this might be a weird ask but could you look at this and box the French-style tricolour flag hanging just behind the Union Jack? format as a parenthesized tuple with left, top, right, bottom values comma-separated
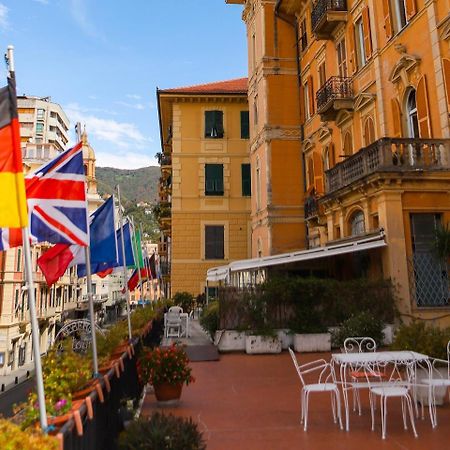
(38, 197, 117, 286)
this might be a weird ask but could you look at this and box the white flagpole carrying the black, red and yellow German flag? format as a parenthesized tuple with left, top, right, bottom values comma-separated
(7, 45, 48, 433)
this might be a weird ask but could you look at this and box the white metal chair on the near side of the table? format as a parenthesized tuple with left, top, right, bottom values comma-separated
(364, 360, 417, 439)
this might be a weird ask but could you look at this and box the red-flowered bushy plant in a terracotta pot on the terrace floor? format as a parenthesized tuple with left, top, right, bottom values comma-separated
(139, 344, 194, 402)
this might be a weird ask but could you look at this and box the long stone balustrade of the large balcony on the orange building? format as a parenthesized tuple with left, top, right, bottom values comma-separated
(326, 138, 450, 194)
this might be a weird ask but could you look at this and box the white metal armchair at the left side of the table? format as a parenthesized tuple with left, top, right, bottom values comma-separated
(289, 348, 342, 431)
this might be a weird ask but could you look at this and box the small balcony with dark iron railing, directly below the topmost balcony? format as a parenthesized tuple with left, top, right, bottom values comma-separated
(316, 77, 353, 122)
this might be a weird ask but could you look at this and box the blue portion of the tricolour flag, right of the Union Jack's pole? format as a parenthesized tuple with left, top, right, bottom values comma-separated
(77, 197, 118, 277)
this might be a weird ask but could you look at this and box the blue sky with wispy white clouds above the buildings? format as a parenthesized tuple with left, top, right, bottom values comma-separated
(0, 0, 247, 168)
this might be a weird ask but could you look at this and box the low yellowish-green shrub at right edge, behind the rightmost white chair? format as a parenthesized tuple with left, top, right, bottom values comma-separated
(392, 321, 450, 359)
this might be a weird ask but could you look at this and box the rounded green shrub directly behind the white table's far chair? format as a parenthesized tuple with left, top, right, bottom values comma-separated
(331, 311, 384, 347)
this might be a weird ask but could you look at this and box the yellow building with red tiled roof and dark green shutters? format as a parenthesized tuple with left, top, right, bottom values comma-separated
(157, 78, 251, 296)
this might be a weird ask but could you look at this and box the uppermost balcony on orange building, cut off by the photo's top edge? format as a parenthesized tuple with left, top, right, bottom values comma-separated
(311, 0, 347, 39)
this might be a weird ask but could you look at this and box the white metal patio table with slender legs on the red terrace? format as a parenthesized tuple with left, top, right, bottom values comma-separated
(331, 350, 436, 431)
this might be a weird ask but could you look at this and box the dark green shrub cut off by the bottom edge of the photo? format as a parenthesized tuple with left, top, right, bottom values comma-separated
(119, 412, 206, 450)
